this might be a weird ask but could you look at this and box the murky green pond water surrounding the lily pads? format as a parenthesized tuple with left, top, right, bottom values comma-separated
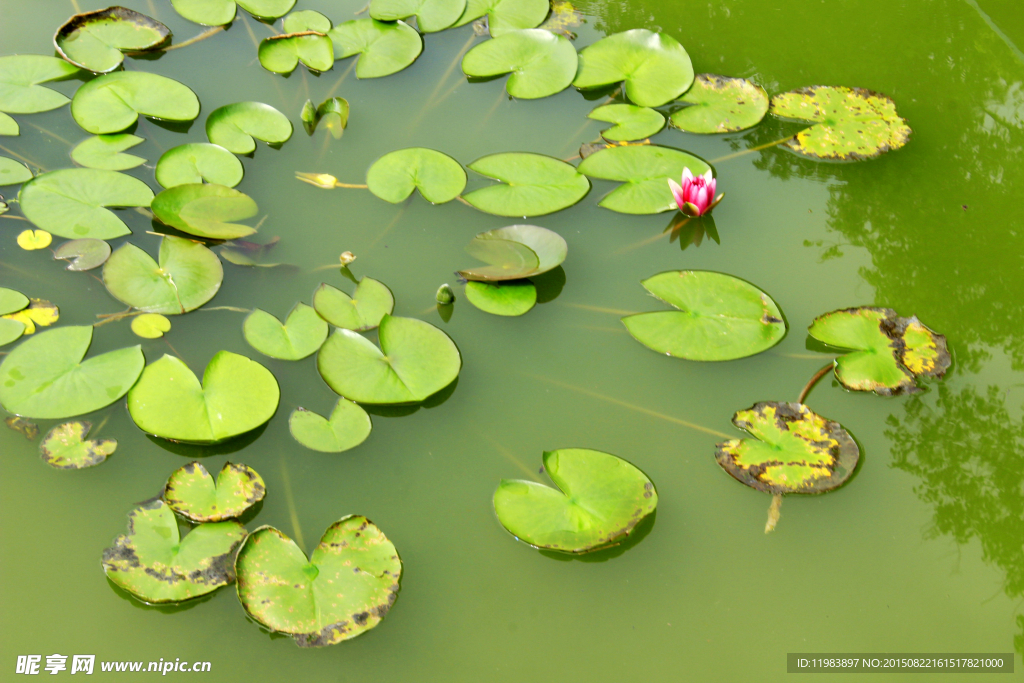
(0, 0, 1024, 683)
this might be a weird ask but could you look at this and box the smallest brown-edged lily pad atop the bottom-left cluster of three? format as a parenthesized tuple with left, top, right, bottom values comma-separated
(163, 461, 266, 522)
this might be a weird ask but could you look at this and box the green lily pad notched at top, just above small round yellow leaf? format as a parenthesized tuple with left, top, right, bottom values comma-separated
(103, 236, 224, 315)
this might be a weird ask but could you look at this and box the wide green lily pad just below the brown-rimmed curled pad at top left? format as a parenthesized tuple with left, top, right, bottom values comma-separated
(71, 71, 199, 135)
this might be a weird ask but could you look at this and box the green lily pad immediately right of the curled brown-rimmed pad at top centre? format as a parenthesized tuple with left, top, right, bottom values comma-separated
(328, 18, 423, 78)
